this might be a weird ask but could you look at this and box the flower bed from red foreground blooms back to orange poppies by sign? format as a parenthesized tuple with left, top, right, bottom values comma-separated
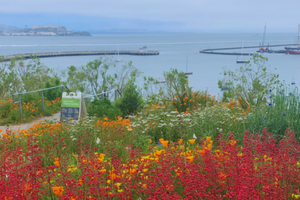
(0, 118, 300, 199)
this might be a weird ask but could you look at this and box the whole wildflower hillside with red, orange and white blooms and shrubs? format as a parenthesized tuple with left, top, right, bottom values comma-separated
(0, 55, 300, 200)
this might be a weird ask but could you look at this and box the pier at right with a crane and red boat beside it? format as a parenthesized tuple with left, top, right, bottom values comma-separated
(199, 44, 298, 56)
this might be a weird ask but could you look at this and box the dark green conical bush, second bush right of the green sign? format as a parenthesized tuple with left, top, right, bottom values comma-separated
(115, 80, 143, 116)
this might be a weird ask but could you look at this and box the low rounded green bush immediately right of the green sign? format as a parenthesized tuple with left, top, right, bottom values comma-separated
(87, 98, 122, 120)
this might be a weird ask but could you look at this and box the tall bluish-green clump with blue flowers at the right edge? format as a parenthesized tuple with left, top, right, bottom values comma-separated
(246, 87, 300, 139)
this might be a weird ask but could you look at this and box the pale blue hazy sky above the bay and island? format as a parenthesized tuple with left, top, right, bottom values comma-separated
(0, 0, 300, 32)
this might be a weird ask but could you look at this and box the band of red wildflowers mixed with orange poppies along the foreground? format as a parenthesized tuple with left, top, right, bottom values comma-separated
(0, 129, 300, 199)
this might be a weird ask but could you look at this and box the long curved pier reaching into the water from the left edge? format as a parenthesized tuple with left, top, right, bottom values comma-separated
(0, 50, 159, 62)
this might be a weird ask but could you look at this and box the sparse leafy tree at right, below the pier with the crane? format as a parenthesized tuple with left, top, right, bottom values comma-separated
(218, 55, 279, 105)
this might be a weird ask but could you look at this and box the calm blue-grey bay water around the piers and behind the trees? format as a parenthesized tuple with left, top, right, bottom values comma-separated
(0, 33, 300, 95)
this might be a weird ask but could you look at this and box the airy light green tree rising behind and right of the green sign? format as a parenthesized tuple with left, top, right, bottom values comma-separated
(67, 58, 141, 95)
